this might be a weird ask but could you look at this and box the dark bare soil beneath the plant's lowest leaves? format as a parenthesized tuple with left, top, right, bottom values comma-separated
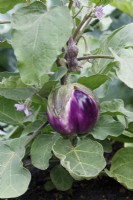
(11, 143, 133, 200)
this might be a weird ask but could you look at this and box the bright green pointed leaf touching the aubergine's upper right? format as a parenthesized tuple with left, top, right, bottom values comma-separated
(78, 74, 109, 90)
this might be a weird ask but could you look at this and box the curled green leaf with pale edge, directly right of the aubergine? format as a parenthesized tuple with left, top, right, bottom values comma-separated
(101, 99, 133, 118)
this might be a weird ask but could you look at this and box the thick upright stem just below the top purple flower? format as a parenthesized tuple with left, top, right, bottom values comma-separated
(73, 11, 92, 40)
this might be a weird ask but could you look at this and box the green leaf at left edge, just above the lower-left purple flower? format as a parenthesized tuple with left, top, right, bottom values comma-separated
(0, 73, 35, 101)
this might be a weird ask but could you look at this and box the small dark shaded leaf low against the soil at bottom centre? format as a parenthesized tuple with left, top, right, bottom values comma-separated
(50, 165, 73, 191)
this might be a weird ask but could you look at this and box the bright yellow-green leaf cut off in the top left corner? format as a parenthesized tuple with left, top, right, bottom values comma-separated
(0, 0, 26, 13)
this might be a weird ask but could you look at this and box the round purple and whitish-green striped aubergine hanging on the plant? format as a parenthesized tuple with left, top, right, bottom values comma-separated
(47, 83, 99, 135)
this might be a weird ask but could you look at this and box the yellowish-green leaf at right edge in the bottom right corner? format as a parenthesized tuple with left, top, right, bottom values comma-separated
(108, 147, 133, 190)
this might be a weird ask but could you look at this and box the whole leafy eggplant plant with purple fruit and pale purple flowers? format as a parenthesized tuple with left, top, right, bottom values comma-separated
(0, 0, 133, 199)
